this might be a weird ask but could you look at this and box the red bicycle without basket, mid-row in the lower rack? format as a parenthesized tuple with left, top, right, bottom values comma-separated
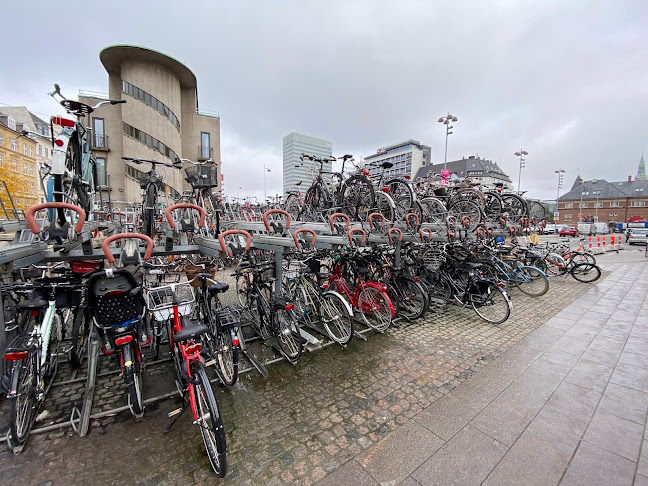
(328, 228, 394, 332)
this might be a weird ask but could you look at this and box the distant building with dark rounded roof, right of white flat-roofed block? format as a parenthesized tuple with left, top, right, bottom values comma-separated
(416, 155, 513, 190)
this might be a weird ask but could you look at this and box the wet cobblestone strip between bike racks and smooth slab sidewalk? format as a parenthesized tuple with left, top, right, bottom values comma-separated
(0, 264, 607, 486)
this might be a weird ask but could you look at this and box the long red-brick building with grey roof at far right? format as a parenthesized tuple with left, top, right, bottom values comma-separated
(558, 155, 648, 225)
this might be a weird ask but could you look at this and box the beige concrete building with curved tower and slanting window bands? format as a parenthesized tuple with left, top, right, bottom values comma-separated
(79, 45, 221, 207)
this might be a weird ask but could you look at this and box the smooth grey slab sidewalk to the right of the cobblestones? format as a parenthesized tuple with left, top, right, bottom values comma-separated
(318, 248, 648, 486)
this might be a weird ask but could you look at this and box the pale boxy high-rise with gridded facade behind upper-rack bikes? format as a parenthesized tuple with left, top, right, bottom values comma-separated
(283, 132, 333, 197)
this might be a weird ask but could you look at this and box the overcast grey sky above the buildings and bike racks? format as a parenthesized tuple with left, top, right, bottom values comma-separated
(0, 0, 648, 199)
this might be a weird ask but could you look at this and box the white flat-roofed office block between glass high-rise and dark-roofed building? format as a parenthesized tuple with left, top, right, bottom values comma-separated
(364, 139, 431, 180)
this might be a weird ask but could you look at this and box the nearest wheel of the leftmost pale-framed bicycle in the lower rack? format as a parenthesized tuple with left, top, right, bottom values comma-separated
(9, 352, 38, 449)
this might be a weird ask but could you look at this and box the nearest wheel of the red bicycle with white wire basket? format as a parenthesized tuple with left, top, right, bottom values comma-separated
(191, 361, 227, 478)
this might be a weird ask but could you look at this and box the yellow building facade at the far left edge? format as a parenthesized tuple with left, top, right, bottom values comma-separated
(0, 115, 39, 214)
